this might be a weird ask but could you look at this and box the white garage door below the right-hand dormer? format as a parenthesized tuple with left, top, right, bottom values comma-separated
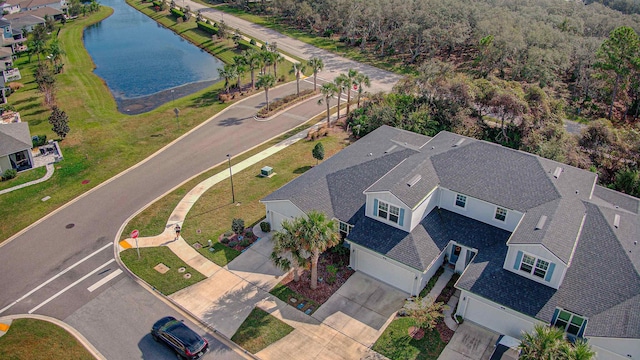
(464, 296, 533, 338)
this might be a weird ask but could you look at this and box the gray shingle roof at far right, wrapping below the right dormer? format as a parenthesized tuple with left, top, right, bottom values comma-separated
(457, 203, 640, 338)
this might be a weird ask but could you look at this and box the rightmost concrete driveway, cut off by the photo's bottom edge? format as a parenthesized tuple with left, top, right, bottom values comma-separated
(438, 321, 499, 360)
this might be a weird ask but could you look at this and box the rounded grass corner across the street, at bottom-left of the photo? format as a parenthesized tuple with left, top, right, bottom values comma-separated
(0, 319, 95, 360)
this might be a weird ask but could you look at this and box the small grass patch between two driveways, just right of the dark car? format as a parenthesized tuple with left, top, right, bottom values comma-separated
(231, 308, 293, 354)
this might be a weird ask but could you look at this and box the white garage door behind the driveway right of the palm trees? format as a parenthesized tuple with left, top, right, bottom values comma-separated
(356, 249, 415, 293)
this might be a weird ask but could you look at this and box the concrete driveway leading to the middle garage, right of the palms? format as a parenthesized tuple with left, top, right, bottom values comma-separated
(312, 272, 409, 347)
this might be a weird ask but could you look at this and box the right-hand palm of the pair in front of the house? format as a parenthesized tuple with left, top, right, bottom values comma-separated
(299, 210, 340, 290)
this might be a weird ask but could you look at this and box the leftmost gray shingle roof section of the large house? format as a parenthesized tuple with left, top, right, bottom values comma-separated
(262, 126, 429, 224)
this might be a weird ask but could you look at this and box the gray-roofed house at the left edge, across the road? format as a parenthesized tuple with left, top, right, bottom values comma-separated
(0, 122, 33, 173)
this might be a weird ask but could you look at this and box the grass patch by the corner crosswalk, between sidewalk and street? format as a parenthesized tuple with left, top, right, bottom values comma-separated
(120, 246, 206, 295)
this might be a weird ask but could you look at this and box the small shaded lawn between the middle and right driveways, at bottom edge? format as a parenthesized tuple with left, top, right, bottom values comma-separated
(373, 317, 447, 360)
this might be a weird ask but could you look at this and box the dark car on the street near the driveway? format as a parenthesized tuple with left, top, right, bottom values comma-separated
(151, 316, 209, 359)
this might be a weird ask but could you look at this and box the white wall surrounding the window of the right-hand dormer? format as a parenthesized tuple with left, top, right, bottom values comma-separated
(502, 244, 567, 289)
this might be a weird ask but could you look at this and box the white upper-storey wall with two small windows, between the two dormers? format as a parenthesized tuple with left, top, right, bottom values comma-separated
(438, 187, 523, 232)
